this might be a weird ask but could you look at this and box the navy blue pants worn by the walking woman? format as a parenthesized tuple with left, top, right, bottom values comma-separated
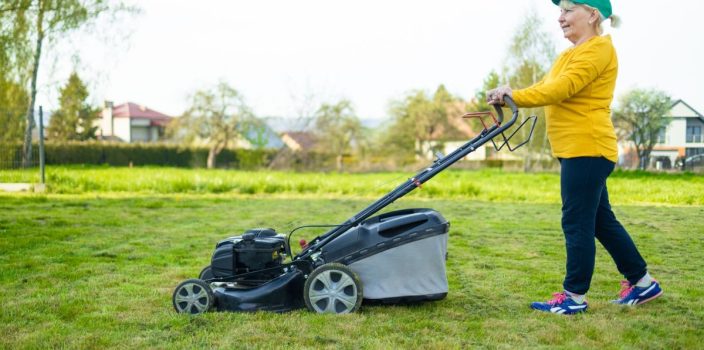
(560, 157, 646, 294)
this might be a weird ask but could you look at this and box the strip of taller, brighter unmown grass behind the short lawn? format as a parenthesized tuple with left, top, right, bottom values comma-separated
(0, 167, 704, 205)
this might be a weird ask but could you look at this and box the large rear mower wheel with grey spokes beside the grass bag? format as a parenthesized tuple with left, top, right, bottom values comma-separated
(303, 263, 362, 314)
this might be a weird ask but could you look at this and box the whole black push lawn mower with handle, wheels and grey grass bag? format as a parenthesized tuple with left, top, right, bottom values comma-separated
(172, 97, 536, 314)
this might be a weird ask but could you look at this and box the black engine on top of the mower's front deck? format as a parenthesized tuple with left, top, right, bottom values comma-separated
(210, 228, 286, 284)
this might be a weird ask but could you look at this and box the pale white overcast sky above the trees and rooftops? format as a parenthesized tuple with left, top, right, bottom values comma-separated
(38, 0, 704, 119)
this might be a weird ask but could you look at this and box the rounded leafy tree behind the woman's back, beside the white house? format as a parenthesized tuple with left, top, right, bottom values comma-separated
(613, 89, 672, 170)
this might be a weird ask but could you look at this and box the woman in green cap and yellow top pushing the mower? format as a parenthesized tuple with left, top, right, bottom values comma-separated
(487, 0, 662, 315)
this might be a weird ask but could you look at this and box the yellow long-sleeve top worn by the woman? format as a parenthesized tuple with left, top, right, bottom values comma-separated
(513, 35, 618, 162)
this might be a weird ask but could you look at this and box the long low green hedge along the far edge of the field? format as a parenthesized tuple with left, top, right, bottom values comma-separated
(0, 142, 554, 171)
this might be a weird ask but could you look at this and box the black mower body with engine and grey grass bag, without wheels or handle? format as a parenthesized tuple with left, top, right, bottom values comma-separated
(206, 209, 450, 312)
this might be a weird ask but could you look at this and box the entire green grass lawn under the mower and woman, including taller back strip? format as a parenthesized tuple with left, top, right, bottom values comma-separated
(0, 168, 704, 349)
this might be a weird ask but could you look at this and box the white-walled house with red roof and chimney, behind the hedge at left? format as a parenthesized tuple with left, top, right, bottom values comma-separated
(95, 101, 173, 143)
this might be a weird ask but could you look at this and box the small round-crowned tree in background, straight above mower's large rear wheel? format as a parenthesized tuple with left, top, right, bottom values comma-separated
(314, 100, 362, 171)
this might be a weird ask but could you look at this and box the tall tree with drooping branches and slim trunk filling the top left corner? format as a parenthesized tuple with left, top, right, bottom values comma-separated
(0, 0, 130, 166)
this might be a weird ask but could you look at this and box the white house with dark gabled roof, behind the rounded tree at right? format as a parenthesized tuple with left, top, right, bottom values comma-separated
(619, 100, 704, 169)
